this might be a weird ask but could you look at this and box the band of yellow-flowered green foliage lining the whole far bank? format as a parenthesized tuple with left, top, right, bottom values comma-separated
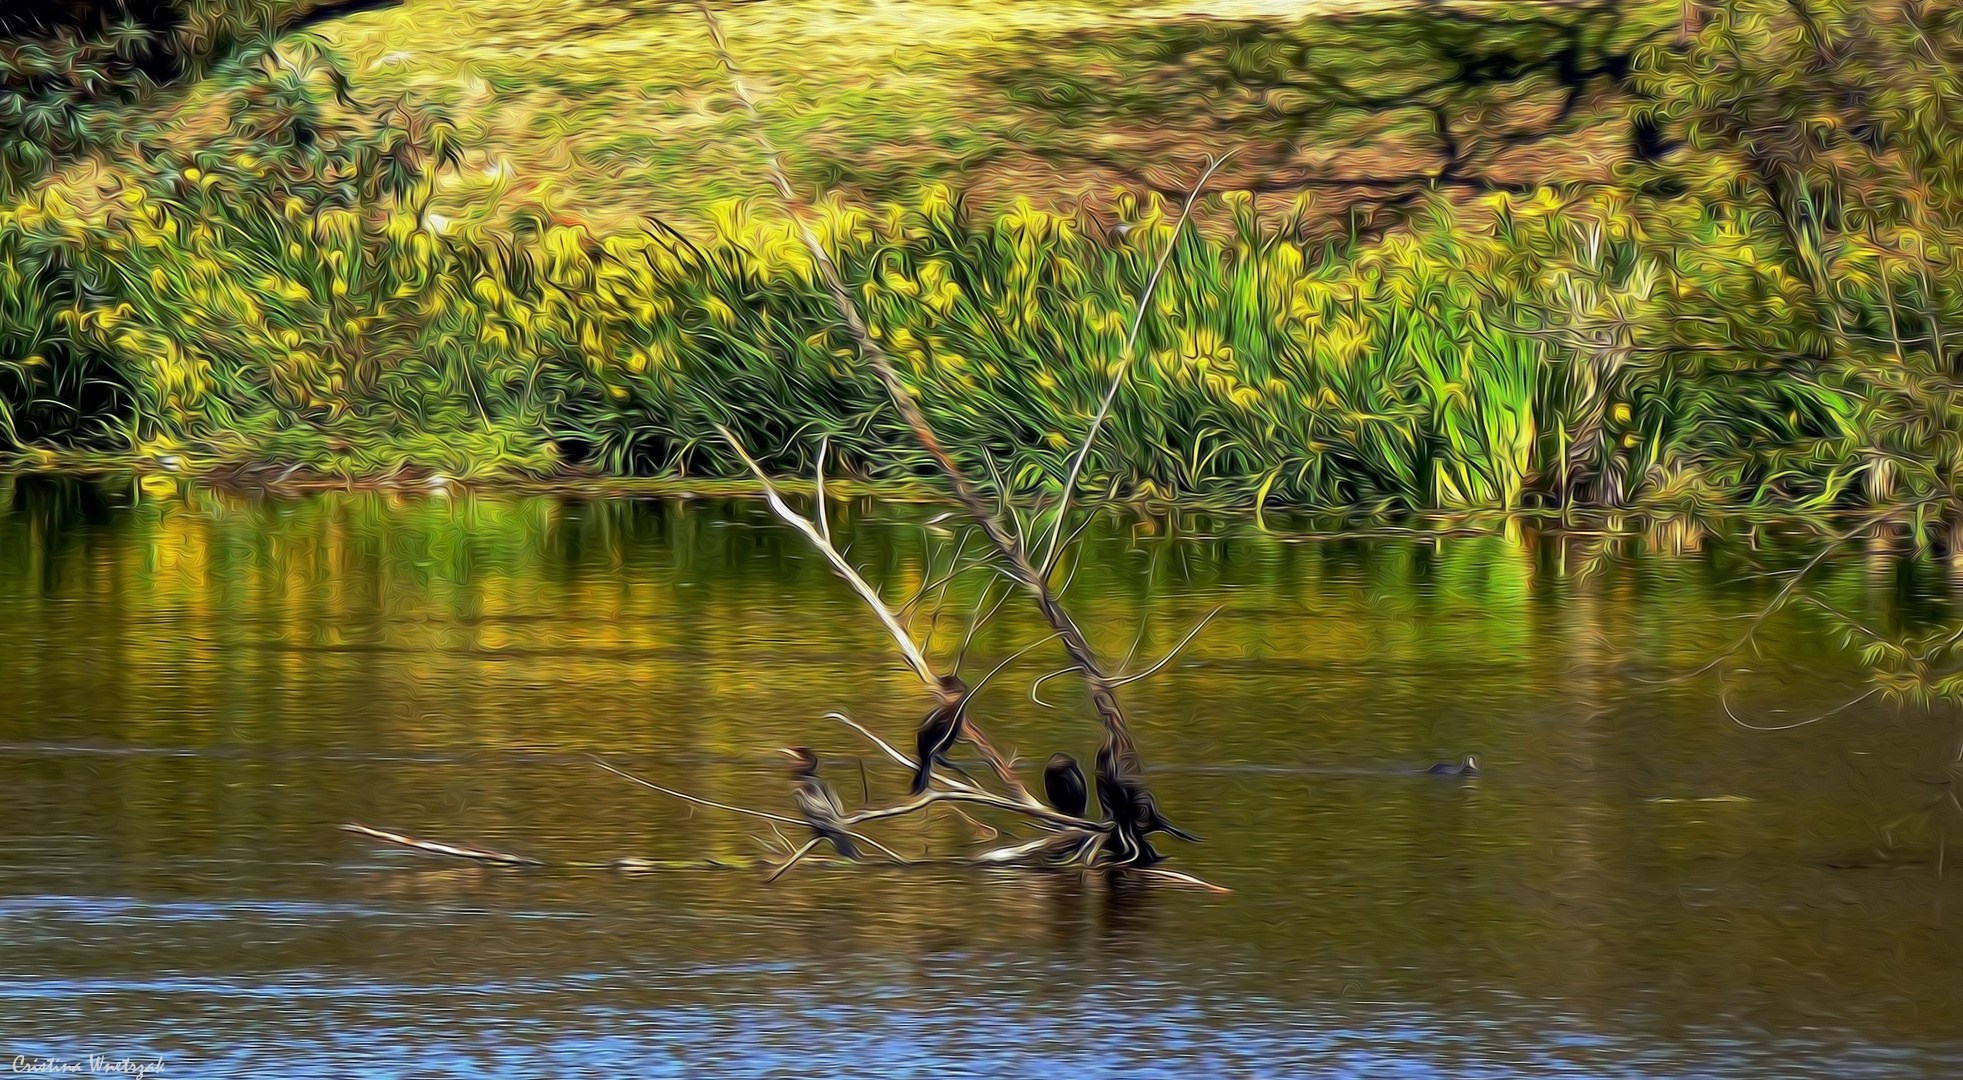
(0, 0, 1963, 520)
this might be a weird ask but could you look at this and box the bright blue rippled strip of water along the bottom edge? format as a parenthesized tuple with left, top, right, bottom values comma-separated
(0, 964, 1963, 1080)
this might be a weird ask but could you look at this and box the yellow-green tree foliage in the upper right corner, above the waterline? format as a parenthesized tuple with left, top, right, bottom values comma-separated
(1643, 0, 1963, 524)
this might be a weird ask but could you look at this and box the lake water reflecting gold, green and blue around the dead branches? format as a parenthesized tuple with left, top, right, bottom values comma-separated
(0, 479, 1963, 1078)
